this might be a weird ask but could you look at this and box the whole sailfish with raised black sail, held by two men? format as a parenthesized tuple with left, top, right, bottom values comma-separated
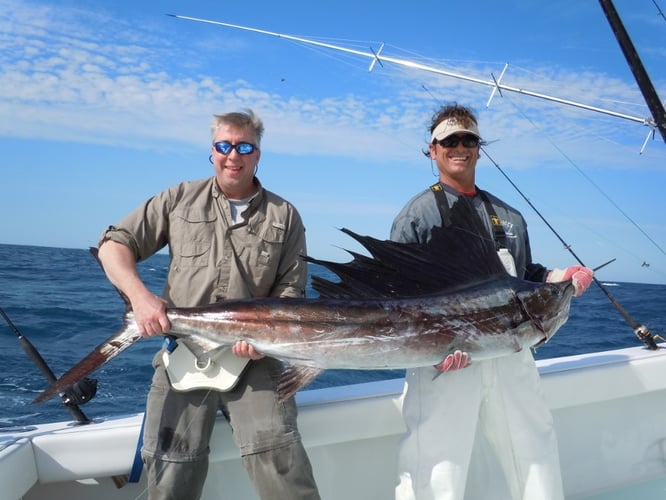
(35, 197, 574, 402)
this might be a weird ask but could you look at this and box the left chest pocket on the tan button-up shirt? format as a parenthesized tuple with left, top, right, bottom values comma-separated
(169, 209, 217, 268)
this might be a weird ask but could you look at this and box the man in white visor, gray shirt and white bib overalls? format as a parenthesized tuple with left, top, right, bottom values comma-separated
(391, 104, 592, 500)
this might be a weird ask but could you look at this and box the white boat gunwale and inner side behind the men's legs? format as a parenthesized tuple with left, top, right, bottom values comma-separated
(0, 346, 666, 500)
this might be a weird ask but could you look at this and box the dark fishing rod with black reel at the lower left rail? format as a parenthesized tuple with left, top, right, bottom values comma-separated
(0, 307, 97, 424)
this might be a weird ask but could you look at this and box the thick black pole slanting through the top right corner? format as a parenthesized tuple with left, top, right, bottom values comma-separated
(599, 0, 666, 143)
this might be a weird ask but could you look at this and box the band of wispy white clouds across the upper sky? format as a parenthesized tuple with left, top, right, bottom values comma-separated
(0, 0, 660, 165)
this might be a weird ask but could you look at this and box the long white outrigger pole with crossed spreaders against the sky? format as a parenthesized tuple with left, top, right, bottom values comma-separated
(167, 14, 666, 135)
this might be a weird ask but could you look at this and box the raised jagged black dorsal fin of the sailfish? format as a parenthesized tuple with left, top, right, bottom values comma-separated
(307, 197, 506, 298)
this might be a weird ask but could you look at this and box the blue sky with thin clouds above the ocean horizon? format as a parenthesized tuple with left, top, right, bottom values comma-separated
(0, 0, 666, 283)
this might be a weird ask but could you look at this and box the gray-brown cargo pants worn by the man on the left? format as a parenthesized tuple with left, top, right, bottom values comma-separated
(142, 351, 320, 500)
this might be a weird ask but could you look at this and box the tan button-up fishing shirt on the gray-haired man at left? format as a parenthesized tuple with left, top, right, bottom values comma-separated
(102, 177, 307, 307)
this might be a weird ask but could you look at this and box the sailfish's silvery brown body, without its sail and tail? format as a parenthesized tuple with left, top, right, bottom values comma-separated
(168, 276, 573, 370)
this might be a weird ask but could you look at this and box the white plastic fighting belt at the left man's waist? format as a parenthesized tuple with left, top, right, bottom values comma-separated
(162, 340, 250, 392)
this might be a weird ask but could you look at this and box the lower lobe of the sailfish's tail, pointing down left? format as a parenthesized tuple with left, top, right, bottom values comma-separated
(33, 320, 141, 404)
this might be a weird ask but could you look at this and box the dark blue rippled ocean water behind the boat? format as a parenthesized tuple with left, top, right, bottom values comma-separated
(0, 244, 666, 427)
